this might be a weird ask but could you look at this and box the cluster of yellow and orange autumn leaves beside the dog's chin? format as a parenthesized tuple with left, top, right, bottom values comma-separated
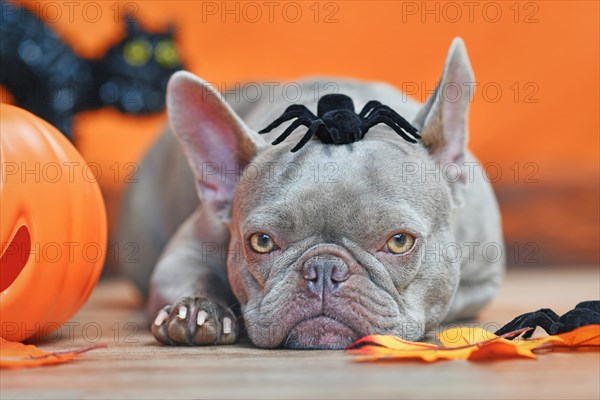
(346, 324, 600, 362)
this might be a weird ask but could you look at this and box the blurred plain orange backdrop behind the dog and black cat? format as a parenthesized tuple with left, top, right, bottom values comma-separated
(9, 1, 600, 268)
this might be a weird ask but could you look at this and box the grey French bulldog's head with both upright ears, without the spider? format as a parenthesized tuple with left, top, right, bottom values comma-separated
(167, 39, 474, 348)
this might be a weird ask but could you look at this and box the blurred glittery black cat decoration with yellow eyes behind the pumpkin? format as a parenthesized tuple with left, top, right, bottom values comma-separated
(0, 0, 182, 138)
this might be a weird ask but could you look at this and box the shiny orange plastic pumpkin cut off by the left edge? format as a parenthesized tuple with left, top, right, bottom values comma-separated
(0, 104, 107, 341)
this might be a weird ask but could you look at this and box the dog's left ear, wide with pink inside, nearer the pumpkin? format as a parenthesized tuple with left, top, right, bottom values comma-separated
(167, 71, 265, 216)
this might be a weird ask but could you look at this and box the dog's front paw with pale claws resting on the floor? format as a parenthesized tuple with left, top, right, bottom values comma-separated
(152, 297, 238, 346)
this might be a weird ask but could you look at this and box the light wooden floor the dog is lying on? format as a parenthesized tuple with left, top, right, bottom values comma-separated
(0, 267, 600, 400)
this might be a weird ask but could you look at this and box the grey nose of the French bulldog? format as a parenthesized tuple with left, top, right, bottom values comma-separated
(302, 256, 350, 295)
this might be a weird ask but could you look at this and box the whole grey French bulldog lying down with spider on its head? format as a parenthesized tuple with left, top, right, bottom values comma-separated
(119, 38, 504, 349)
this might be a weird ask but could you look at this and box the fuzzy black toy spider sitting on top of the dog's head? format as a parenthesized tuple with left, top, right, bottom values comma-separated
(258, 94, 421, 153)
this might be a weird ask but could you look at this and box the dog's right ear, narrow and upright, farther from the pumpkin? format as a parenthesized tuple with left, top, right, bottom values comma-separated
(413, 37, 475, 203)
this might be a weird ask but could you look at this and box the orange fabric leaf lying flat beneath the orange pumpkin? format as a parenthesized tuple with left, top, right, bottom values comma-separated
(0, 337, 106, 368)
